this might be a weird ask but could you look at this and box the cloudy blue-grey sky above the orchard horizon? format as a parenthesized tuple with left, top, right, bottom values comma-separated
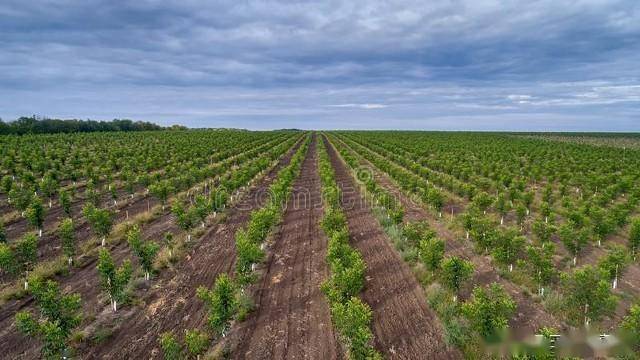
(0, 0, 640, 131)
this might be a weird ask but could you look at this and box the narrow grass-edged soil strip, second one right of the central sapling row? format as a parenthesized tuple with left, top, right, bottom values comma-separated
(330, 134, 566, 338)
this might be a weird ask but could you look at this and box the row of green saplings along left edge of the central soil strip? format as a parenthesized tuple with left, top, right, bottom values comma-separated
(159, 134, 308, 360)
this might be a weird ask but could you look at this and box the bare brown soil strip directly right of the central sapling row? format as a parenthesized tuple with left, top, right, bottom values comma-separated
(323, 136, 462, 359)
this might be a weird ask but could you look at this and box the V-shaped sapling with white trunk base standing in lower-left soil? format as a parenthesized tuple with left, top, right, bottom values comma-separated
(97, 249, 132, 312)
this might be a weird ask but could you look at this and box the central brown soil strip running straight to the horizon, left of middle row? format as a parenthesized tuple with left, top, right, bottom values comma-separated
(229, 135, 341, 359)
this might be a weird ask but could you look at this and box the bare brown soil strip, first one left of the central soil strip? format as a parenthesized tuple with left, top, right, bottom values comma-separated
(81, 141, 302, 359)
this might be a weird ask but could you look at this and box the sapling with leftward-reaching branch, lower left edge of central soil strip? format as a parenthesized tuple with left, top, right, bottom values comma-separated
(197, 273, 238, 337)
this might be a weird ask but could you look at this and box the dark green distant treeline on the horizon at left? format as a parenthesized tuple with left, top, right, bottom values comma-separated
(0, 116, 164, 135)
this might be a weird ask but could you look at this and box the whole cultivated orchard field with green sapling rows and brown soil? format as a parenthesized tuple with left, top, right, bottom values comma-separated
(0, 130, 640, 359)
